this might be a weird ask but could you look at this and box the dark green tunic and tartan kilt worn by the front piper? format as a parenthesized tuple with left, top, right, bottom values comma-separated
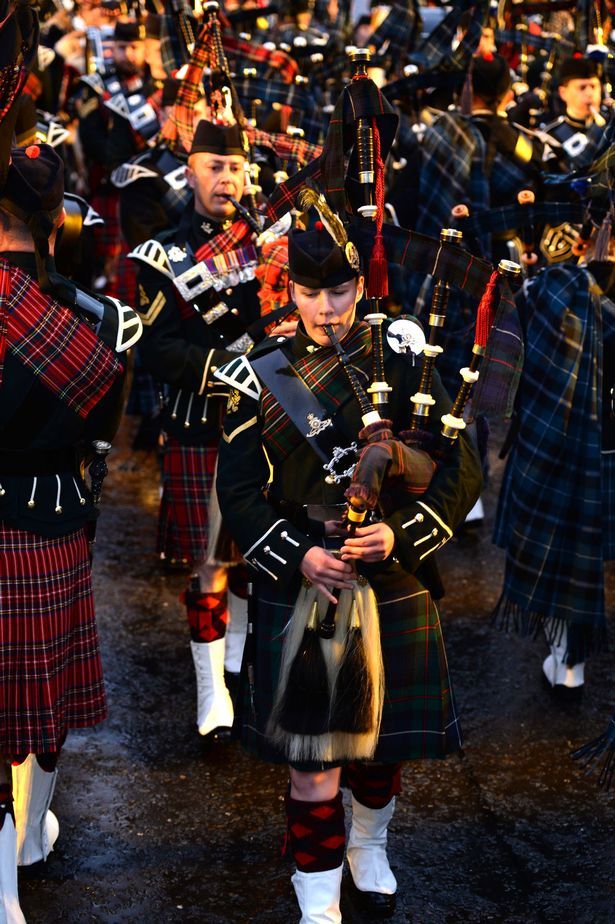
(217, 323, 481, 762)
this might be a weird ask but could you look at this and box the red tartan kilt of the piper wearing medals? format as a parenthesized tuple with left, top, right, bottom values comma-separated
(156, 437, 218, 567)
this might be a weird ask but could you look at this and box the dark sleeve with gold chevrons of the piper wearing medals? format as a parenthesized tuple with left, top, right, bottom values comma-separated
(135, 266, 237, 395)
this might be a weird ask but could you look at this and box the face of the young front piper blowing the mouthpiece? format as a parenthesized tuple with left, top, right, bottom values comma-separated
(288, 276, 363, 346)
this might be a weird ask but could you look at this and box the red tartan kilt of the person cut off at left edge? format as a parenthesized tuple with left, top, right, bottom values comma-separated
(0, 523, 107, 755)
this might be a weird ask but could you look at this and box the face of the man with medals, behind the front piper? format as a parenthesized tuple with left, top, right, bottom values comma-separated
(186, 154, 245, 221)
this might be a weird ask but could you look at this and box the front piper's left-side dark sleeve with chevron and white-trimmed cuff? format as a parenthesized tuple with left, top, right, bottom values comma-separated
(216, 390, 314, 587)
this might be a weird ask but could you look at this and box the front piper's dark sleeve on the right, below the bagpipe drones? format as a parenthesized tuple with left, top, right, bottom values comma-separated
(385, 372, 482, 574)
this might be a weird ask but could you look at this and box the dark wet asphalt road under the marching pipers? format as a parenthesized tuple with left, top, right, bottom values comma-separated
(20, 419, 615, 924)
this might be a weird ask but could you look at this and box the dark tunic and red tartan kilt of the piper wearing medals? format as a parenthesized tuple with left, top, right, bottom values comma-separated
(132, 212, 260, 566)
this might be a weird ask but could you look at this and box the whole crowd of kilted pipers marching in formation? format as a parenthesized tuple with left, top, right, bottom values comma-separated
(0, 0, 615, 924)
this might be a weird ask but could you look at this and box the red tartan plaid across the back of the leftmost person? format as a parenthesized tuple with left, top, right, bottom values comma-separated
(0, 260, 122, 418)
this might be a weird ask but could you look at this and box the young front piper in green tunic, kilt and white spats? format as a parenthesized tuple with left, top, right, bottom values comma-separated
(218, 229, 481, 924)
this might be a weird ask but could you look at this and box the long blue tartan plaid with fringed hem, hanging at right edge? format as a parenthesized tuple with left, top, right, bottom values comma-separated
(494, 266, 614, 661)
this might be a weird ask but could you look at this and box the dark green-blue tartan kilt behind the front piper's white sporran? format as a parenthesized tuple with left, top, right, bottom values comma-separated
(241, 562, 462, 763)
